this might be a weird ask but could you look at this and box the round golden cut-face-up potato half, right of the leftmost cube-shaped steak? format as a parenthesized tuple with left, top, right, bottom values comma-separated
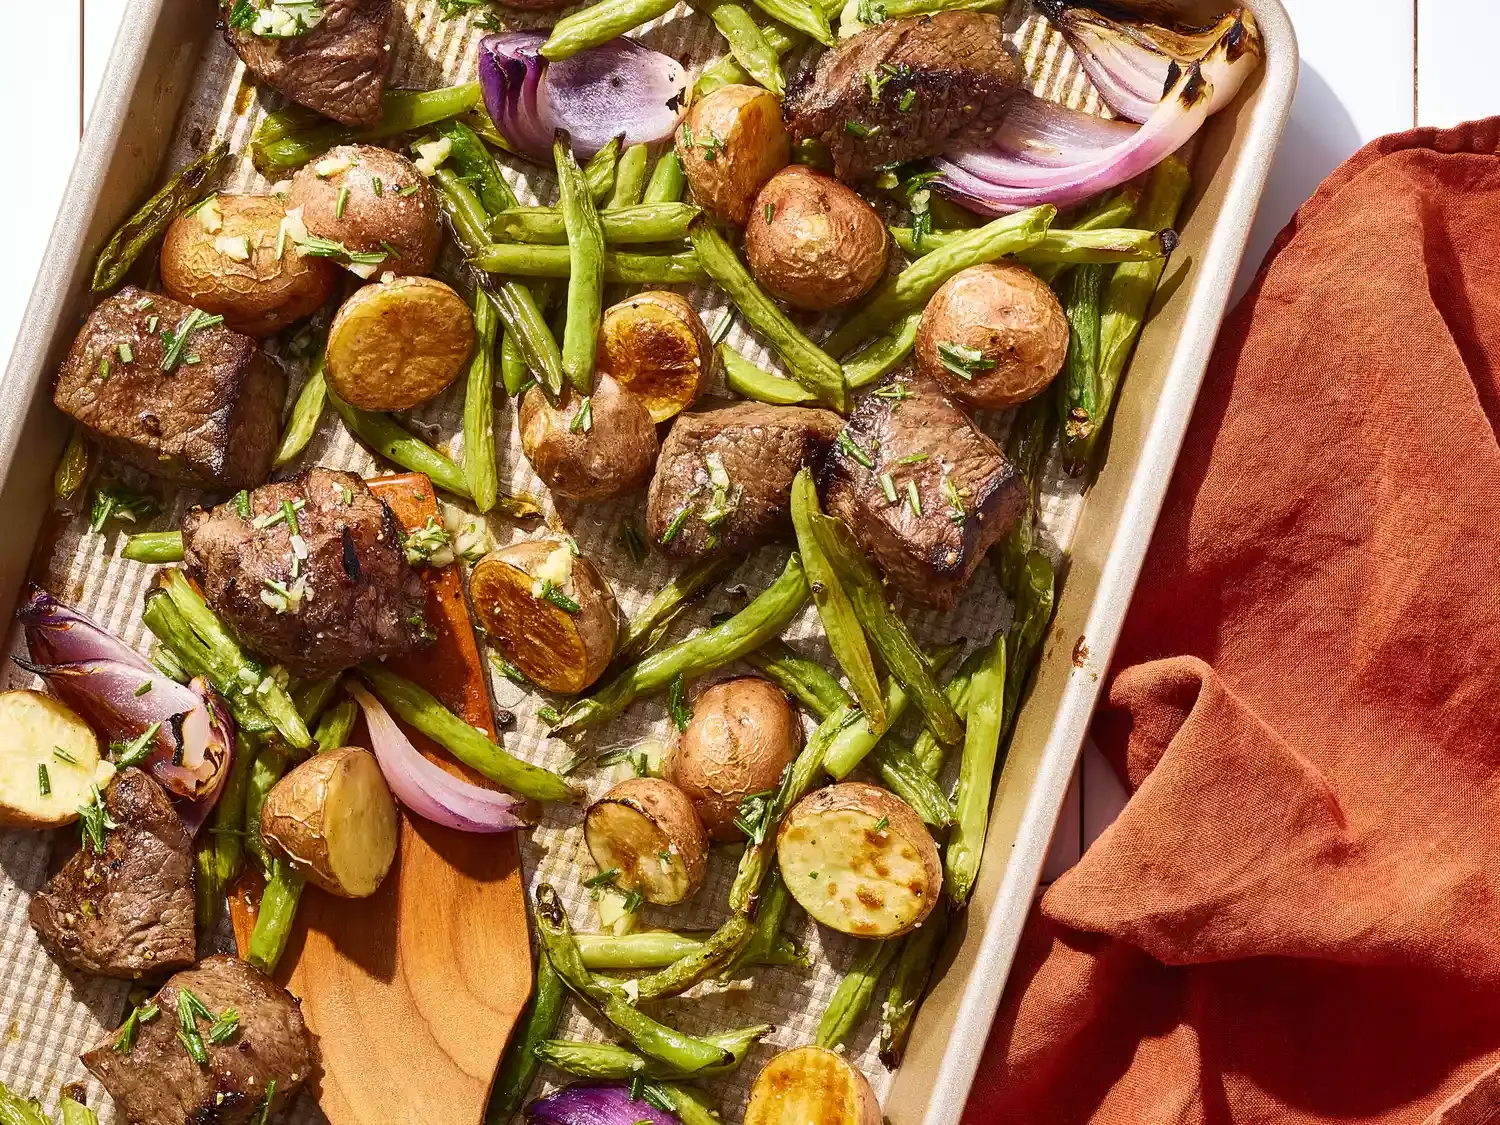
(327, 278, 474, 411)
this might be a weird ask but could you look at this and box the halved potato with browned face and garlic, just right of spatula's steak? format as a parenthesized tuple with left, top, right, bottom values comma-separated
(470, 539, 620, 695)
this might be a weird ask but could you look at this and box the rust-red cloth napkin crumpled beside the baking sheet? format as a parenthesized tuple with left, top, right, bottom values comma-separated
(965, 119, 1500, 1125)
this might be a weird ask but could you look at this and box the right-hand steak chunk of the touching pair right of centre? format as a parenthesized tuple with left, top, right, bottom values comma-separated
(822, 374, 1026, 609)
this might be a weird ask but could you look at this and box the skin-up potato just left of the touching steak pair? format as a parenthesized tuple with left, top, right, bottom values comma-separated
(518, 372, 659, 500)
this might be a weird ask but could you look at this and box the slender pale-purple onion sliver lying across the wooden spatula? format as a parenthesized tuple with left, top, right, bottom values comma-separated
(344, 680, 528, 833)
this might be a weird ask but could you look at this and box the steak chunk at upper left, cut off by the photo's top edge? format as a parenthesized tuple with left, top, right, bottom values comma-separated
(221, 0, 393, 125)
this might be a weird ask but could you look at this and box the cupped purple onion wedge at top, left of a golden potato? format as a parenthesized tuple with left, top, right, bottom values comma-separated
(479, 32, 689, 165)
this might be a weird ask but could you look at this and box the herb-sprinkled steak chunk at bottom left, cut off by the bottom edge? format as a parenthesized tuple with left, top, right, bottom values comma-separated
(81, 954, 314, 1125)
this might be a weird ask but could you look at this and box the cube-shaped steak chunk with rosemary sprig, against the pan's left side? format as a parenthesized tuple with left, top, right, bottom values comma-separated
(53, 285, 287, 489)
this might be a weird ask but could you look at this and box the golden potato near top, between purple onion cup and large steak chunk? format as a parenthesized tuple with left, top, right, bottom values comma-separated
(677, 86, 792, 227)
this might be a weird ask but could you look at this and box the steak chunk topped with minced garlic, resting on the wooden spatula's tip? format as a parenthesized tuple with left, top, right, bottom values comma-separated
(183, 468, 428, 677)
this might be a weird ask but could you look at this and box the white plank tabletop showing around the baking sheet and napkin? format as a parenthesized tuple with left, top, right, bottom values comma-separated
(0, 0, 1500, 879)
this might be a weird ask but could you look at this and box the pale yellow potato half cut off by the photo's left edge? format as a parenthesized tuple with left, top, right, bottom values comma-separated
(0, 692, 114, 828)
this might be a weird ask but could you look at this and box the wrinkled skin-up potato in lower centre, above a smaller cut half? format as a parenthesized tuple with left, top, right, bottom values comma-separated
(663, 677, 803, 842)
